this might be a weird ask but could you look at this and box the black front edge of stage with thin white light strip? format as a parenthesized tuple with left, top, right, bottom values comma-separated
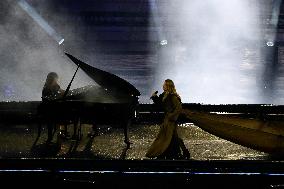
(0, 159, 283, 188)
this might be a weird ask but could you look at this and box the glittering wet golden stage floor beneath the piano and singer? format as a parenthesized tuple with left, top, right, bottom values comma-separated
(0, 124, 271, 160)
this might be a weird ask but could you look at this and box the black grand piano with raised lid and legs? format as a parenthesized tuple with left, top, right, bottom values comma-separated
(36, 53, 140, 147)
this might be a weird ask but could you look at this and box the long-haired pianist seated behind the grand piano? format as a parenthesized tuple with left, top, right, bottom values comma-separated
(41, 72, 64, 102)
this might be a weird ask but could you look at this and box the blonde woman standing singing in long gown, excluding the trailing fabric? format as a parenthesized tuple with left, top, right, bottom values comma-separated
(146, 79, 190, 159)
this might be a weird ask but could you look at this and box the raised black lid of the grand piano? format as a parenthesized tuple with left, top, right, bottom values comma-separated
(65, 52, 140, 96)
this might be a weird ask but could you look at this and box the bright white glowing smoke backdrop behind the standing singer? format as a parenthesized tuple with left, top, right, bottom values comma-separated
(152, 0, 264, 104)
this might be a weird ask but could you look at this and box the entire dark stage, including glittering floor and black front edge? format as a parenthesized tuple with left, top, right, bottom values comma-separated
(0, 102, 284, 188)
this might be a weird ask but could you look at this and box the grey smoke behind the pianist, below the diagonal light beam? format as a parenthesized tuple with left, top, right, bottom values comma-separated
(0, 0, 93, 101)
